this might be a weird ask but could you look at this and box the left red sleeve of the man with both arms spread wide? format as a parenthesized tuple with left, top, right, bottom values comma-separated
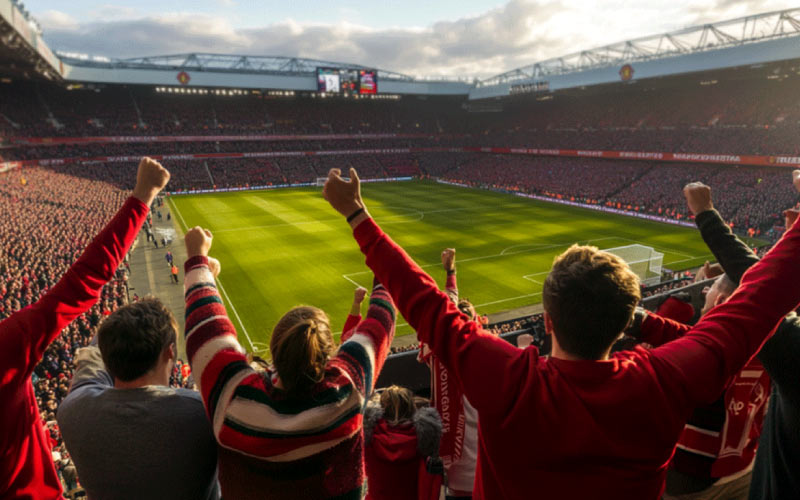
(354, 219, 538, 413)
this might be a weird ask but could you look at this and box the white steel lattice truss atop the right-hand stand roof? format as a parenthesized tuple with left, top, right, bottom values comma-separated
(478, 8, 800, 86)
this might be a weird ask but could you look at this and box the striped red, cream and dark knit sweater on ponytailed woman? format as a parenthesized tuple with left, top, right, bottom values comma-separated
(185, 257, 395, 499)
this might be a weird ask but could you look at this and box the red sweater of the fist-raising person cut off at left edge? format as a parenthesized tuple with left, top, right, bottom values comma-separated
(0, 197, 147, 500)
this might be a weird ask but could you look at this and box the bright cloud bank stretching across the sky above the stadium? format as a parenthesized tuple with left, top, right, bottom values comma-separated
(39, 0, 788, 77)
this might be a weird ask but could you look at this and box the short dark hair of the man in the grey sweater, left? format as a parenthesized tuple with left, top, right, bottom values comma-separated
(97, 297, 178, 382)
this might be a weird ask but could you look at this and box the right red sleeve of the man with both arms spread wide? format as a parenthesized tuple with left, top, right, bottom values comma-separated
(651, 217, 800, 407)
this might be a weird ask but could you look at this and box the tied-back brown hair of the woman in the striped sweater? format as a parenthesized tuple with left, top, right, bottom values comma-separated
(269, 306, 336, 394)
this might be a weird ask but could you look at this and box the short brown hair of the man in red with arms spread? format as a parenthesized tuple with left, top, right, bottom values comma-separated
(542, 245, 641, 359)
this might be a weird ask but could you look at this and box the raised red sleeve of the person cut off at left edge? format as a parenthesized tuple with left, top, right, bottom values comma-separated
(0, 197, 148, 387)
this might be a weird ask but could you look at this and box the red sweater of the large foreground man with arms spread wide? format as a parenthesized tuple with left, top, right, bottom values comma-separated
(354, 219, 800, 499)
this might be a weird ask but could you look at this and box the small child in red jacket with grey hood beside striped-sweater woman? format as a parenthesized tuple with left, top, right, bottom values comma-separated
(364, 385, 442, 500)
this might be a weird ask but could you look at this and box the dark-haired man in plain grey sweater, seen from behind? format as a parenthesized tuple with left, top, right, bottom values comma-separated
(58, 297, 219, 500)
